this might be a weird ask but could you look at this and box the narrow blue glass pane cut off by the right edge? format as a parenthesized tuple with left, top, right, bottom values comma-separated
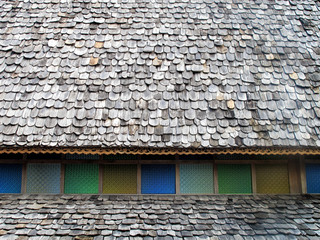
(306, 164, 320, 193)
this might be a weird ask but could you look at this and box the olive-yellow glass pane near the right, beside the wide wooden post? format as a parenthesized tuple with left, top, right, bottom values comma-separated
(256, 164, 290, 194)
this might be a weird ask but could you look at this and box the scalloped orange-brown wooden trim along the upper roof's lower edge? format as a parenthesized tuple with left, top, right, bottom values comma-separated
(0, 147, 320, 155)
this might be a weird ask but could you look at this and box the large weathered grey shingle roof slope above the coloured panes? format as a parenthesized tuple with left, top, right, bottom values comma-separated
(0, 0, 320, 147)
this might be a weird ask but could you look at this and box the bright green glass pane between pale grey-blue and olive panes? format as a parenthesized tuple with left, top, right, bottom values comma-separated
(64, 164, 99, 194)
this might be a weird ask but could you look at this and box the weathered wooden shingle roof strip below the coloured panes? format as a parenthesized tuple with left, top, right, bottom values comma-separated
(0, 195, 320, 240)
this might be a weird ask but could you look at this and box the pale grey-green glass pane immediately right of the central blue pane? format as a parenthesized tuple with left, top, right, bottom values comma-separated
(180, 164, 214, 194)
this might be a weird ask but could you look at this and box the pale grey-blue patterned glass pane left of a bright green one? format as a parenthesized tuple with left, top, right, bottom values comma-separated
(27, 163, 61, 193)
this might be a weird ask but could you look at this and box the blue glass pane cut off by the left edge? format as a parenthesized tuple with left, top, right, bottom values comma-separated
(0, 164, 22, 193)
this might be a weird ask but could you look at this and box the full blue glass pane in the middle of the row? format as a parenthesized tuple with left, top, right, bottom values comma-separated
(141, 164, 176, 194)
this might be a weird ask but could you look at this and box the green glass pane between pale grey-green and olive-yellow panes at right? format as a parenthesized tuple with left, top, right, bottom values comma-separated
(218, 164, 252, 194)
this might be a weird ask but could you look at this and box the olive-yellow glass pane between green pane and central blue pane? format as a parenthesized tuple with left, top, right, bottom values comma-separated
(103, 164, 137, 194)
